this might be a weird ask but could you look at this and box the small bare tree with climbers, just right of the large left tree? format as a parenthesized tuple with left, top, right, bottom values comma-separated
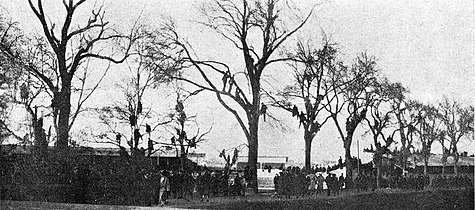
(93, 60, 173, 156)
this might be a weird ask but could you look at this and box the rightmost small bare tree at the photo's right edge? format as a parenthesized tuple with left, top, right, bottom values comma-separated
(439, 97, 474, 174)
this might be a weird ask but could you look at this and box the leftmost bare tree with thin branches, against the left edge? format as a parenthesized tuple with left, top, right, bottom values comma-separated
(0, 16, 45, 144)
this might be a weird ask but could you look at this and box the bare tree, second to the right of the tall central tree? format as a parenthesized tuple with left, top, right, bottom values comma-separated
(325, 53, 377, 182)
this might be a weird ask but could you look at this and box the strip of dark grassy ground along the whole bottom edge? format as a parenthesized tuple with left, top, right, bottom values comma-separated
(0, 189, 474, 210)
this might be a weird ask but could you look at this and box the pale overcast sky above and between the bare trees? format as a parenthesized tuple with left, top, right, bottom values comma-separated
(0, 0, 475, 162)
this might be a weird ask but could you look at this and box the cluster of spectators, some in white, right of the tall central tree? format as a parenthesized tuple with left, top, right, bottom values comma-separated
(274, 167, 345, 197)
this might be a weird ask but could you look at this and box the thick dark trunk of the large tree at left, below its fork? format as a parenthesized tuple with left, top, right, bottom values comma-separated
(57, 82, 71, 149)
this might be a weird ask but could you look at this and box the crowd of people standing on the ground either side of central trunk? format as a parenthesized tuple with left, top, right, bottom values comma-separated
(148, 167, 473, 205)
